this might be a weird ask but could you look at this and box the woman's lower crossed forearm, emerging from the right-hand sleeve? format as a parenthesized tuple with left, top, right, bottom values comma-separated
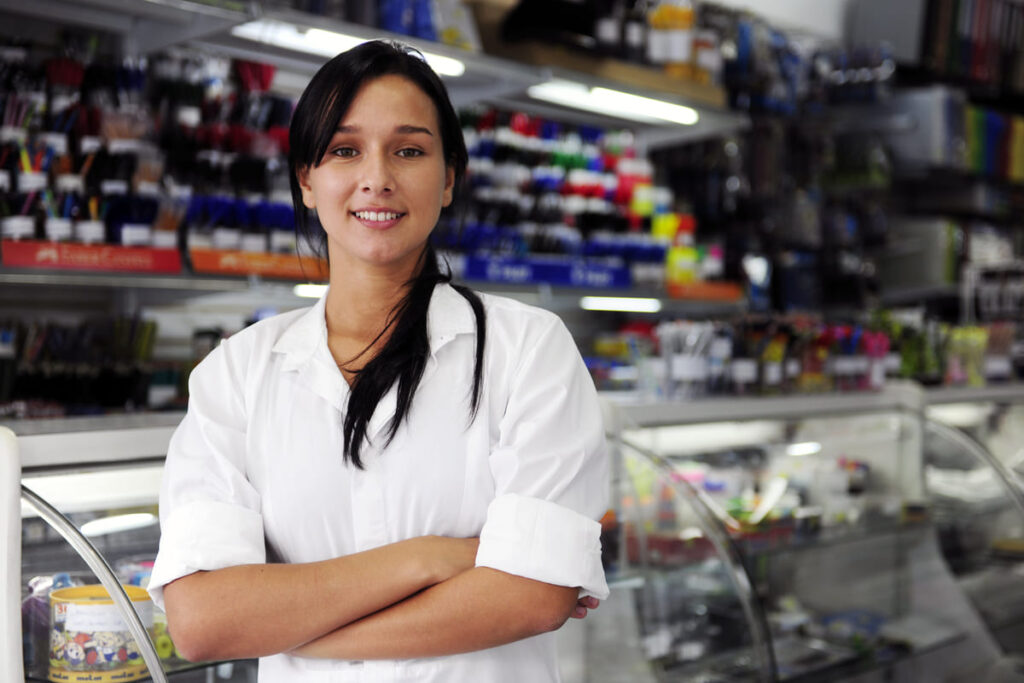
(292, 567, 580, 659)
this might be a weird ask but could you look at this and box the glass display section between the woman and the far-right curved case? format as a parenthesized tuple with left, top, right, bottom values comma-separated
(595, 408, 997, 681)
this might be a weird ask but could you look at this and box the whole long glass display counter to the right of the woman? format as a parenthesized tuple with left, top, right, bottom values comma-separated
(591, 383, 1024, 682)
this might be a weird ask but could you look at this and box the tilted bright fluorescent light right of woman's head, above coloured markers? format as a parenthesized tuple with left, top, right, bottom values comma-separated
(526, 79, 699, 126)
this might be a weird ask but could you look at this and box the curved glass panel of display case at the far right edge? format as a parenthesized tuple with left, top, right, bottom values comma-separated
(925, 404, 1024, 658)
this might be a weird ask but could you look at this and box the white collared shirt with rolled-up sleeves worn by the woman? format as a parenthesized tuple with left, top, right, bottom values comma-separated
(150, 285, 608, 683)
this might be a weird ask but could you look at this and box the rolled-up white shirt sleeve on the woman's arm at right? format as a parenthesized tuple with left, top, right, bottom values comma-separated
(476, 318, 609, 599)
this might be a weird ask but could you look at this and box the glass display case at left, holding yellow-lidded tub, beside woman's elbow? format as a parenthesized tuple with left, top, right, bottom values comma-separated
(0, 415, 256, 683)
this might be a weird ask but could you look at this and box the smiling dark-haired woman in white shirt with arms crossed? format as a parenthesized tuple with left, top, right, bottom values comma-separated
(150, 42, 608, 683)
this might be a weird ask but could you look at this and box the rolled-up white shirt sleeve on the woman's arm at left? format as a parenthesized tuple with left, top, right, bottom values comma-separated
(148, 345, 266, 608)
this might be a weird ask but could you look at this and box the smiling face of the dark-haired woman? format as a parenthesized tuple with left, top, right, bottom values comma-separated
(299, 75, 455, 276)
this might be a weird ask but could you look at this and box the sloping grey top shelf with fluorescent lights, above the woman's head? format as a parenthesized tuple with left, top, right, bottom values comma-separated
(0, 0, 748, 146)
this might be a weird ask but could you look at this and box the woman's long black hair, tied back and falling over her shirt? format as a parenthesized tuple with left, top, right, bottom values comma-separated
(288, 41, 486, 469)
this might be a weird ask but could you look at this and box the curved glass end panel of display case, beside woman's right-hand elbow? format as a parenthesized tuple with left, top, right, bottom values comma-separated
(588, 441, 771, 682)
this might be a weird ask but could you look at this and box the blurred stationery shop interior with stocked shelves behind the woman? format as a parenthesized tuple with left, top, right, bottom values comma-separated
(6, 0, 1024, 683)
